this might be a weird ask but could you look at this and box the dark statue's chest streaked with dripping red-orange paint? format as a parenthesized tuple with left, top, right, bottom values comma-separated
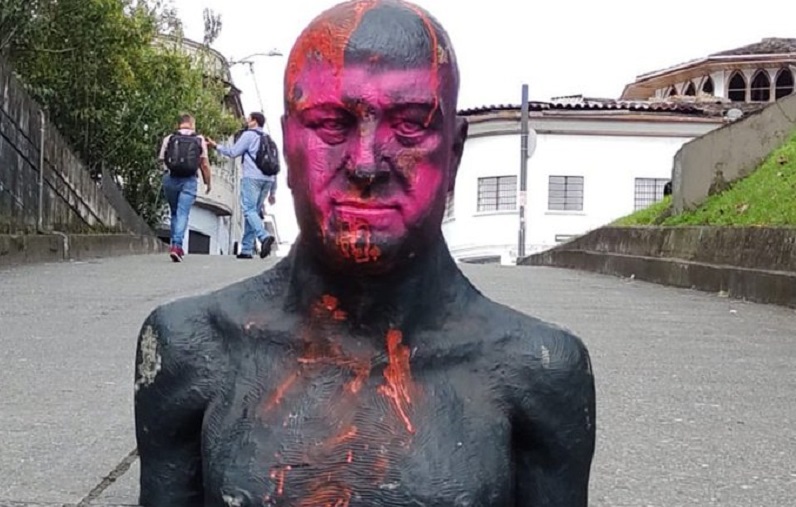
(203, 342, 512, 507)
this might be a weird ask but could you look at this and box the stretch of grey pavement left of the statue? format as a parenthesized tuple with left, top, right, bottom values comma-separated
(0, 254, 274, 506)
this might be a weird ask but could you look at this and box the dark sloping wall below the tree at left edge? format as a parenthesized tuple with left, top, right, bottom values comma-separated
(0, 61, 152, 235)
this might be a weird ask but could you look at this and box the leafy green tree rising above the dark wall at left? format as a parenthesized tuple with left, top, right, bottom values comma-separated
(0, 0, 238, 225)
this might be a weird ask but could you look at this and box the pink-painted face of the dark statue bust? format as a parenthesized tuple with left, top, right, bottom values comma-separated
(284, 63, 453, 268)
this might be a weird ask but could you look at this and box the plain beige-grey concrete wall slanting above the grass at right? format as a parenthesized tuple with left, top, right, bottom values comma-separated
(672, 95, 796, 213)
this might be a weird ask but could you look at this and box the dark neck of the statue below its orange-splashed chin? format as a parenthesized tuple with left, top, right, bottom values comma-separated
(286, 235, 472, 334)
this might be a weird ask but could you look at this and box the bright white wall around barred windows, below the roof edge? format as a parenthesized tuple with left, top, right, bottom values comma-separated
(443, 125, 704, 263)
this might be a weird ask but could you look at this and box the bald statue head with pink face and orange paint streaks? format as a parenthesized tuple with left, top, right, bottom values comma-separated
(282, 0, 467, 273)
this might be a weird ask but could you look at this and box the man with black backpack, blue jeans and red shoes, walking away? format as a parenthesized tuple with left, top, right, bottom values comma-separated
(158, 113, 211, 262)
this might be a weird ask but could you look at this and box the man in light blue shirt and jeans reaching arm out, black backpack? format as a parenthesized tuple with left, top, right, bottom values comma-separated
(207, 112, 280, 259)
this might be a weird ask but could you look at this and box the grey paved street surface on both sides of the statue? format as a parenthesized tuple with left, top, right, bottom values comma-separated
(0, 256, 796, 507)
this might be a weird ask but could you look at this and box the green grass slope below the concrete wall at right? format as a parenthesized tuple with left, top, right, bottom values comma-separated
(612, 134, 796, 227)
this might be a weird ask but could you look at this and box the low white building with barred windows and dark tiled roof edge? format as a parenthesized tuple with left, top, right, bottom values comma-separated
(443, 97, 725, 264)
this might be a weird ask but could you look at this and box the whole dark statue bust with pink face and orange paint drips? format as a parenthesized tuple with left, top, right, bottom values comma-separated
(135, 0, 595, 507)
